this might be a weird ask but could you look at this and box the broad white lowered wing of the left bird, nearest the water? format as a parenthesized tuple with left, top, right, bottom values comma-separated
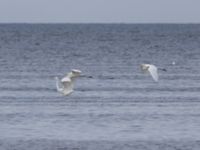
(61, 77, 73, 95)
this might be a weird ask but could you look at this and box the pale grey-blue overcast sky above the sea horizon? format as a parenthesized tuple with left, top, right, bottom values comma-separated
(0, 0, 200, 23)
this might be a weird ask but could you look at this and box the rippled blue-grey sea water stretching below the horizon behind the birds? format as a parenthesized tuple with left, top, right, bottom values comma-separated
(0, 24, 200, 150)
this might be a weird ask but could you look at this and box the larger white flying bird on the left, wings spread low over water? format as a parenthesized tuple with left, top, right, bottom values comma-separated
(55, 69, 81, 96)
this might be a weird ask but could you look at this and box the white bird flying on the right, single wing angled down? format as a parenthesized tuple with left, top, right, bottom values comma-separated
(140, 64, 158, 82)
